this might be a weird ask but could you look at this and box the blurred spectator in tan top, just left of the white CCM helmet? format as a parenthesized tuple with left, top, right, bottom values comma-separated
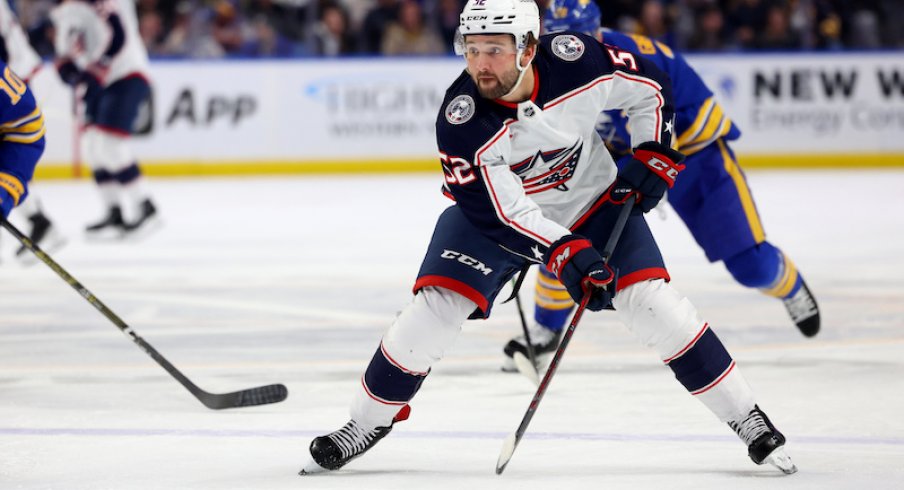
(382, 0, 447, 56)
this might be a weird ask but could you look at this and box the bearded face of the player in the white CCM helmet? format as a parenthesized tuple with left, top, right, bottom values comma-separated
(465, 34, 518, 99)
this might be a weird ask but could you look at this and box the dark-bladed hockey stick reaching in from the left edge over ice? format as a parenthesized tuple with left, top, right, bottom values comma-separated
(0, 216, 289, 410)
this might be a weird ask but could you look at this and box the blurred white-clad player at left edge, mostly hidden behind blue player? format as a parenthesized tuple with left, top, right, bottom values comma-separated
(0, 0, 65, 259)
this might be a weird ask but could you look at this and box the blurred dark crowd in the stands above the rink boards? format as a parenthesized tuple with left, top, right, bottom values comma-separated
(15, 0, 904, 58)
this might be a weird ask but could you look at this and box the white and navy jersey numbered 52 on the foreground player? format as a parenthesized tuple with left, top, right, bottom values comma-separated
(436, 32, 673, 261)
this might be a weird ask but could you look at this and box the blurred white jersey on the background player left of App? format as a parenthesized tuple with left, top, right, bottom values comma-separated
(50, 0, 149, 86)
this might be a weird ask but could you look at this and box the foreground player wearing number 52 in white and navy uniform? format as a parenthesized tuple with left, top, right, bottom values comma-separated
(301, 0, 796, 475)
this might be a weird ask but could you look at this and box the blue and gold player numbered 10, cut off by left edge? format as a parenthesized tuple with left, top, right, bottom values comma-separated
(0, 62, 45, 226)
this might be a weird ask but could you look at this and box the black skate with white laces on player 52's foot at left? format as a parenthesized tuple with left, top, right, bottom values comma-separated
(298, 405, 411, 475)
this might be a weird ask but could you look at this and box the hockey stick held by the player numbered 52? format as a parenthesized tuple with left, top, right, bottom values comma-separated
(496, 195, 635, 475)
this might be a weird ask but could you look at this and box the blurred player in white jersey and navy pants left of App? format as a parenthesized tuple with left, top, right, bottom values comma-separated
(50, 0, 158, 238)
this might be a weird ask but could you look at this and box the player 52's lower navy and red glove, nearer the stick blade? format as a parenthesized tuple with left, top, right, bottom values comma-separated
(544, 235, 615, 311)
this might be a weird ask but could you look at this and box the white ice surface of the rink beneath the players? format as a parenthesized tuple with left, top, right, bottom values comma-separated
(0, 171, 904, 490)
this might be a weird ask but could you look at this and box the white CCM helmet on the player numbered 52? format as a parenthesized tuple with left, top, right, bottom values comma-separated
(455, 0, 540, 55)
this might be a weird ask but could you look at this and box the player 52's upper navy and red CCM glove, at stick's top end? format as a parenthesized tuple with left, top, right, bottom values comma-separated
(610, 141, 684, 213)
